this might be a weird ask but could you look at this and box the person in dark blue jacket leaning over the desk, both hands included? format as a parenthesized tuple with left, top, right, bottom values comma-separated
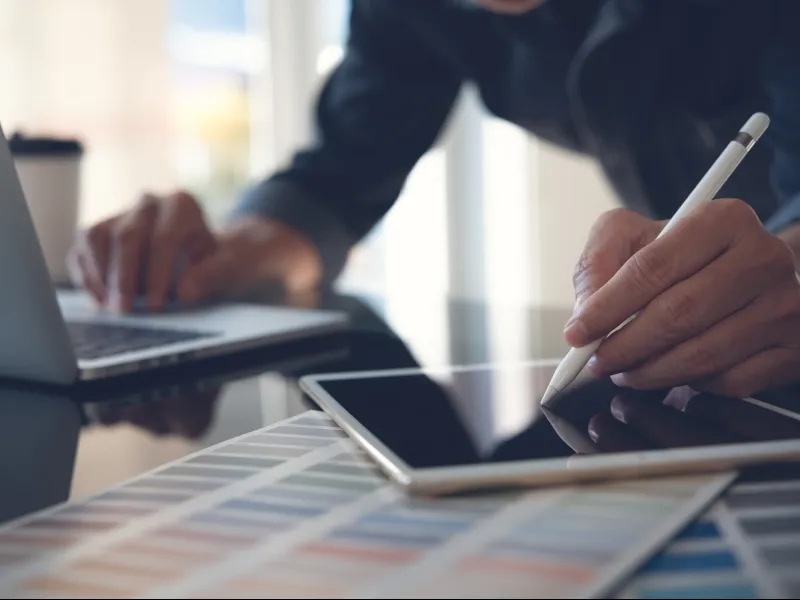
(70, 0, 800, 396)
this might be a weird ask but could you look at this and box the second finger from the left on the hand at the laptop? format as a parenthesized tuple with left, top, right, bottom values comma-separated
(108, 202, 156, 312)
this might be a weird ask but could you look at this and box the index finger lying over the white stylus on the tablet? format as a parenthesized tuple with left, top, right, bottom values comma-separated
(565, 200, 763, 347)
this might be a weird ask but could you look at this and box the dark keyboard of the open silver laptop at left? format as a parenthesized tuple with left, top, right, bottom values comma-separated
(67, 321, 213, 359)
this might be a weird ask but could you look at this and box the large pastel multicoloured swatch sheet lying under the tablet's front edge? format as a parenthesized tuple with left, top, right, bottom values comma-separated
(0, 412, 732, 598)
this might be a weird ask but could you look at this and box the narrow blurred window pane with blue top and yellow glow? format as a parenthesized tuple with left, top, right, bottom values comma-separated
(167, 0, 262, 221)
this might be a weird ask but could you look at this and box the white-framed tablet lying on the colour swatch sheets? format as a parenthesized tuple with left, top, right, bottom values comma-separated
(301, 360, 800, 494)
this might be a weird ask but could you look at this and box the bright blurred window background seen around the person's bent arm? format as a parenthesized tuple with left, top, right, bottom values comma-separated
(0, 0, 614, 305)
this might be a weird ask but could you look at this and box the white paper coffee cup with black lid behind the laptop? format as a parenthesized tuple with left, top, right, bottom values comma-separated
(9, 134, 83, 284)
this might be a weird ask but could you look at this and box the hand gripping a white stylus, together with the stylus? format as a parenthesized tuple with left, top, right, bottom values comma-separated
(543, 115, 800, 403)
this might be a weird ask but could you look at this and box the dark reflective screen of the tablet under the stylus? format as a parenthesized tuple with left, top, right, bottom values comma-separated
(310, 364, 800, 469)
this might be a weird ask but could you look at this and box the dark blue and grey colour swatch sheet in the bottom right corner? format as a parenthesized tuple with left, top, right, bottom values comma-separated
(622, 480, 800, 598)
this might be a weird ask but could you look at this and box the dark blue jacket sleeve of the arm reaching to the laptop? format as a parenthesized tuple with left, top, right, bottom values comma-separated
(234, 0, 461, 281)
